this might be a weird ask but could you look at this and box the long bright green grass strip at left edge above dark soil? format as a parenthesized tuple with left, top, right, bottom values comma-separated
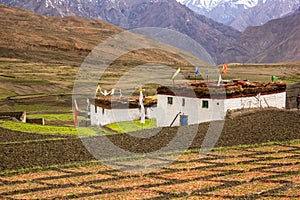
(0, 121, 97, 136)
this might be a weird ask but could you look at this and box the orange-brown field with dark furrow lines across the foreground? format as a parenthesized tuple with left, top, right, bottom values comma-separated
(0, 141, 300, 199)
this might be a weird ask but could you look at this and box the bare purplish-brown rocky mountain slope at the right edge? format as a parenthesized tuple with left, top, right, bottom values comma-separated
(222, 12, 300, 63)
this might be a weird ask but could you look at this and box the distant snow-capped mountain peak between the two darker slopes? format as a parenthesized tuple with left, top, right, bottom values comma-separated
(177, 0, 300, 31)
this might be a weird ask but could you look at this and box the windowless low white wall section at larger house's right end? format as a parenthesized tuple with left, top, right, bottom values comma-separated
(225, 92, 286, 111)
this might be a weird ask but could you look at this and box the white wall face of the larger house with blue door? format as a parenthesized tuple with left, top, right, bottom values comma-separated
(155, 92, 286, 127)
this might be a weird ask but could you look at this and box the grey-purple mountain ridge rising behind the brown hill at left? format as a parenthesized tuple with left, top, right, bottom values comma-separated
(0, 0, 240, 63)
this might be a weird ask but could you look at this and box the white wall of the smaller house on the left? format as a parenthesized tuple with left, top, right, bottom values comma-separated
(90, 104, 155, 126)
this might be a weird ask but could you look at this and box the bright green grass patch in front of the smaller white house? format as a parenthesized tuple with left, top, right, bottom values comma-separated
(106, 119, 156, 133)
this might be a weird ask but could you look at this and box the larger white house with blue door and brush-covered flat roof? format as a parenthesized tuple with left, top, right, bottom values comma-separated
(156, 82, 286, 127)
